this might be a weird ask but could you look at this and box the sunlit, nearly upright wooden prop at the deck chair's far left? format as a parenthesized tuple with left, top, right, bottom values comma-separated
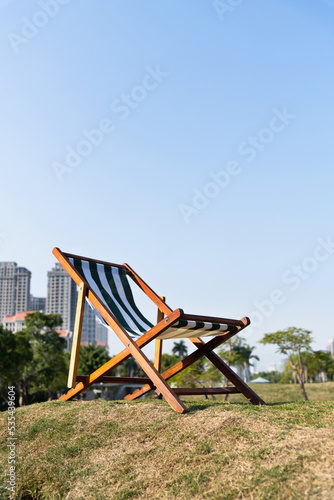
(67, 283, 87, 388)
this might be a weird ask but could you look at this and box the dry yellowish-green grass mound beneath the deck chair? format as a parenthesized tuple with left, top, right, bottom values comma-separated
(0, 383, 334, 500)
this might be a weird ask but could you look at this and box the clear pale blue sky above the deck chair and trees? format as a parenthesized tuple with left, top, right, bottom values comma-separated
(0, 0, 334, 369)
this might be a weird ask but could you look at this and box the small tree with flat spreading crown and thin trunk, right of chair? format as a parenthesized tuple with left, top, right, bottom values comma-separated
(260, 327, 313, 401)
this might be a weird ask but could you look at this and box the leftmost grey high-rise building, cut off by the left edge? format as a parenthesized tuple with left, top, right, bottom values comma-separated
(0, 262, 31, 322)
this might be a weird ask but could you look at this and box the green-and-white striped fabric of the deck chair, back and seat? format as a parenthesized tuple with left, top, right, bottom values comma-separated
(69, 258, 229, 339)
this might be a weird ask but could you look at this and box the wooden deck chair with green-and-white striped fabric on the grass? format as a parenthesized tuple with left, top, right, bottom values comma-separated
(53, 248, 265, 413)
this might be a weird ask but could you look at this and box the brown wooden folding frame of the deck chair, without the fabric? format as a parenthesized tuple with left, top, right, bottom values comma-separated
(53, 248, 265, 413)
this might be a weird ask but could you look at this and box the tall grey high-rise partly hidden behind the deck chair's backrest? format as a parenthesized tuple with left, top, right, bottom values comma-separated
(46, 262, 95, 348)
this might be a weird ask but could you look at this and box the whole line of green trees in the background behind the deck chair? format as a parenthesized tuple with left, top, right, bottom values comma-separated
(0, 312, 334, 406)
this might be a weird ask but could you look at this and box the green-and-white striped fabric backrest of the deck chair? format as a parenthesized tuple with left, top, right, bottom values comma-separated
(68, 257, 153, 336)
